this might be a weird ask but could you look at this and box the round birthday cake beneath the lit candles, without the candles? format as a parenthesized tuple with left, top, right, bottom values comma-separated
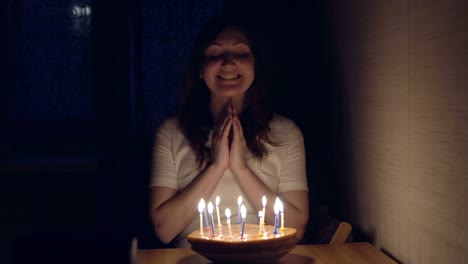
(187, 224, 298, 263)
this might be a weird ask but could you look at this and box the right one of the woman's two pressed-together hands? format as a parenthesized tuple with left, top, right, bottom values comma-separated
(229, 105, 247, 175)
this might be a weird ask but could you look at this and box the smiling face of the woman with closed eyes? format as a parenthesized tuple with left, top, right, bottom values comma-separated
(201, 26, 255, 98)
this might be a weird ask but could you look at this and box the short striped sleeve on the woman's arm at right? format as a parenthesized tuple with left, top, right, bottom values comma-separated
(278, 121, 308, 193)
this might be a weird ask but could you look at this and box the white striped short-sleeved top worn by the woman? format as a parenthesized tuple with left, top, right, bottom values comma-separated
(150, 115, 308, 247)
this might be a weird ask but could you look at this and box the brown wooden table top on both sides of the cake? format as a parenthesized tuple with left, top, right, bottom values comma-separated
(137, 243, 396, 264)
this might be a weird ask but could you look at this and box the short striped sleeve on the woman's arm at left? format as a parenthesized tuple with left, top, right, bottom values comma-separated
(150, 119, 178, 190)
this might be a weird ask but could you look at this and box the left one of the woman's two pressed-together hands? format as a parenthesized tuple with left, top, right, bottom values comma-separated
(212, 106, 233, 171)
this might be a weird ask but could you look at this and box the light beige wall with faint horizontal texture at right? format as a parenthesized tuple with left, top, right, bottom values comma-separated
(330, 0, 468, 263)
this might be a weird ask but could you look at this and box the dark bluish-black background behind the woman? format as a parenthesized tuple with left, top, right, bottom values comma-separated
(0, 0, 340, 263)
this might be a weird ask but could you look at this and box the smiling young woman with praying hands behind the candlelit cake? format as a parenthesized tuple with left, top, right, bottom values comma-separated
(150, 17, 309, 247)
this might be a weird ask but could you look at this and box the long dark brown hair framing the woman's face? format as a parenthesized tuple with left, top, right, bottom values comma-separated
(179, 16, 273, 169)
